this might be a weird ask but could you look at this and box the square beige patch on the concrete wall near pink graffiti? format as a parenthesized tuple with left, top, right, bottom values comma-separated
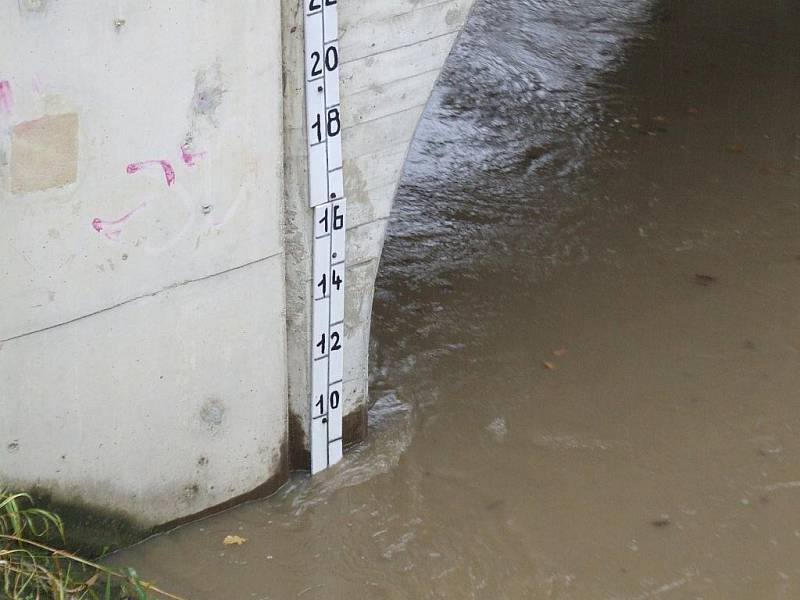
(11, 113, 78, 194)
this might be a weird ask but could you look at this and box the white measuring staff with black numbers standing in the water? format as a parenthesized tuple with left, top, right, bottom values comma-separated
(300, 0, 346, 473)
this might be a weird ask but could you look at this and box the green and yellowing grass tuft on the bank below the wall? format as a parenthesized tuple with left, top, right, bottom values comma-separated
(0, 489, 183, 600)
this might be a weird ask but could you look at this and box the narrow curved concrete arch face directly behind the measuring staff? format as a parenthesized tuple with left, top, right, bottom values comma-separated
(284, 0, 474, 469)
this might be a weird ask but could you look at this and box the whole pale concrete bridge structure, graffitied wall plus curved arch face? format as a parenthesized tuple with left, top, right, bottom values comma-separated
(0, 0, 471, 528)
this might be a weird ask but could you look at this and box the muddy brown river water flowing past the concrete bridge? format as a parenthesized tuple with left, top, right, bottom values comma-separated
(117, 0, 800, 600)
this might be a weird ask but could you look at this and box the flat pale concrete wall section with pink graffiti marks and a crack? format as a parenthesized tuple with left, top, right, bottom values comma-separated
(0, 0, 287, 525)
